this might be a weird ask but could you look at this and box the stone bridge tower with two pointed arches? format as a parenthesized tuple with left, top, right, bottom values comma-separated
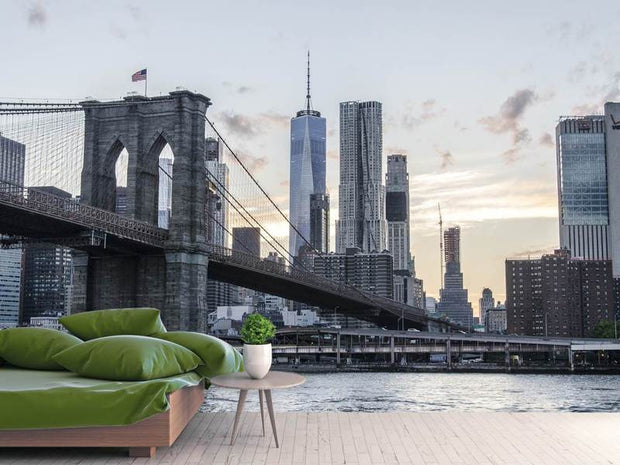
(72, 91, 210, 331)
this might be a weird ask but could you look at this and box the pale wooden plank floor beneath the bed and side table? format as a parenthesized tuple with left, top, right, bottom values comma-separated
(0, 411, 620, 465)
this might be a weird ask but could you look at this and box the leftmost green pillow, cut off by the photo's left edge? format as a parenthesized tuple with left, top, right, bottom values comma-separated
(0, 328, 82, 370)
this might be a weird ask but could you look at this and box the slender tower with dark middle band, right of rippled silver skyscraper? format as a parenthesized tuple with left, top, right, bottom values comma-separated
(385, 155, 412, 274)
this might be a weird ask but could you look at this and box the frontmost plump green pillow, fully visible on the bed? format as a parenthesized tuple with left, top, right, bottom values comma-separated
(54, 336, 202, 381)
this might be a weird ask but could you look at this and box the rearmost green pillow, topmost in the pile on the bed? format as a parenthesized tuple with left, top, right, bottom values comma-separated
(59, 308, 166, 341)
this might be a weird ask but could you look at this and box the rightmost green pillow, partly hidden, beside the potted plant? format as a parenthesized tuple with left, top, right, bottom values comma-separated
(154, 331, 243, 378)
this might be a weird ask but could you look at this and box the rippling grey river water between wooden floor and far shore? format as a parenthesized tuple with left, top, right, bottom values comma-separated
(204, 373, 620, 412)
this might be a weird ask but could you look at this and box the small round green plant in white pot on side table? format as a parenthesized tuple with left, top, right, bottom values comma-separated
(241, 313, 276, 379)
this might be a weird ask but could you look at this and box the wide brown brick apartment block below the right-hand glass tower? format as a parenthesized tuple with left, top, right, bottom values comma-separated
(506, 249, 615, 337)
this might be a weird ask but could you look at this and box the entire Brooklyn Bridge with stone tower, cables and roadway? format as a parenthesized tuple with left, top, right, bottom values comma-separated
(0, 90, 447, 331)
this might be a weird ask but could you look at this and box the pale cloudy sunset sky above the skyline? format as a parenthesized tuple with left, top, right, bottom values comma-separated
(0, 0, 620, 311)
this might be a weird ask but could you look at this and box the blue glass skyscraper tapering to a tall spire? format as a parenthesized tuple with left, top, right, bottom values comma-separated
(289, 53, 329, 256)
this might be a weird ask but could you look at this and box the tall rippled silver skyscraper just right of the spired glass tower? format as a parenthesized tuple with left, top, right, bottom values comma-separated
(336, 101, 386, 253)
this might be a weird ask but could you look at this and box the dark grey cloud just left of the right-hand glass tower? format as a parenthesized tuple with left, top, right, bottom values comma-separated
(478, 89, 536, 163)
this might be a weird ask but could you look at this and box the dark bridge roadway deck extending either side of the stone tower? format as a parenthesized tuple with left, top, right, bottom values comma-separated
(0, 181, 436, 329)
